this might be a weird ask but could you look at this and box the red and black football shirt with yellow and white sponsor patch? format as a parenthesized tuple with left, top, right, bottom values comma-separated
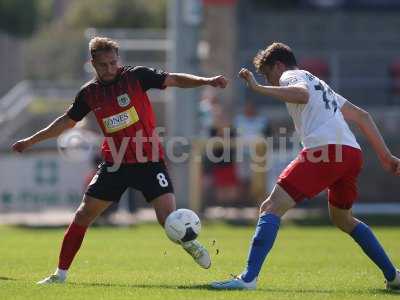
(67, 66, 168, 163)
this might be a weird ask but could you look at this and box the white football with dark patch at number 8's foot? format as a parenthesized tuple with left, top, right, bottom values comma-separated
(164, 208, 201, 243)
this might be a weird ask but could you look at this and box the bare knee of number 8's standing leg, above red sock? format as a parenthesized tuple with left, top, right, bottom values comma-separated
(74, 194, 112, 226)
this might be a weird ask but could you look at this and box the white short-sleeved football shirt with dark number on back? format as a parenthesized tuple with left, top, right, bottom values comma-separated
(279, 70, 361, 149)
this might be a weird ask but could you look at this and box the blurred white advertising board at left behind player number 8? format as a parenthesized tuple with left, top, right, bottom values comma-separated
(0, 152, 90, 213)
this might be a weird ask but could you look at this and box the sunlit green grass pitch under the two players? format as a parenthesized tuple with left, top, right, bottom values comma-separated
(0, 224, 400, 300)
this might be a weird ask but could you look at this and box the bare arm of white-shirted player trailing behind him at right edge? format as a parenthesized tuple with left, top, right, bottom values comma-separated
(341, 101, 400, 176)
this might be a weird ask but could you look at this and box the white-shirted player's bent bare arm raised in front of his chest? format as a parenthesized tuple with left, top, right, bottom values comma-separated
(239, 68, 310, 104)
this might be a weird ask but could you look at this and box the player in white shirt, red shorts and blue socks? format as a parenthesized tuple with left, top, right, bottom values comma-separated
(211, 43, 400, 290)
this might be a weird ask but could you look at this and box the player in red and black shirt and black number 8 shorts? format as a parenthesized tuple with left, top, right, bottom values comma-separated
(12, 37, 227, 284)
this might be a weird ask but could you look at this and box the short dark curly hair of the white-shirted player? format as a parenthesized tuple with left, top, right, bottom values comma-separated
(253, 42, 297, 73)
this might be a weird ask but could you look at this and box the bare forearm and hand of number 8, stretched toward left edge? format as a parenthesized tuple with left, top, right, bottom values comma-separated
(12, 114, 76, 152)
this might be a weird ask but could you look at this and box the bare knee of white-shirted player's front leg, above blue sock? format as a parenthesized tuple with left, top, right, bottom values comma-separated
(260, 184, 296, 217)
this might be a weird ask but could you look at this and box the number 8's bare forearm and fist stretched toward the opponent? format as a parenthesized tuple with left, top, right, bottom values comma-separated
(164, 73, 228, 88)
